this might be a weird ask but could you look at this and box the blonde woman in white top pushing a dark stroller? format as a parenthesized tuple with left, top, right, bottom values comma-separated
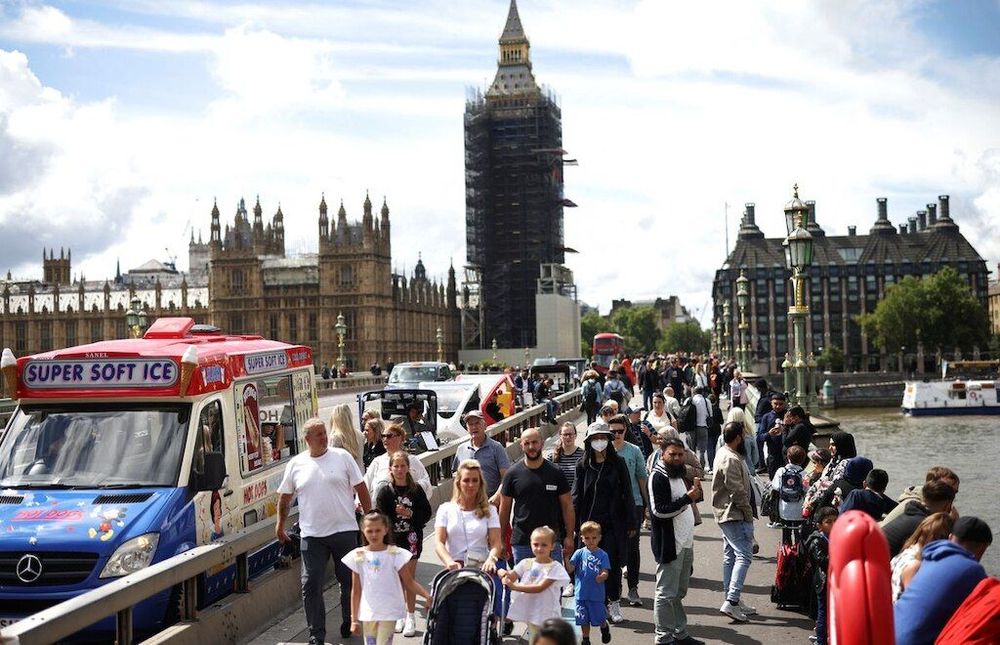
(434, 459, 504, 616)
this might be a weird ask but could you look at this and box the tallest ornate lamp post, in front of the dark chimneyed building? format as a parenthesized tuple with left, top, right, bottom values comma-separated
(782, 184, 813, 406)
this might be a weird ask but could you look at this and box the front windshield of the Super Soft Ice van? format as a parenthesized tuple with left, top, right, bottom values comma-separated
(0, 403, 191, 488)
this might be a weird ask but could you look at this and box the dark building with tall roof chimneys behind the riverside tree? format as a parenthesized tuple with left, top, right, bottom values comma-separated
(712, 195, 989, 374)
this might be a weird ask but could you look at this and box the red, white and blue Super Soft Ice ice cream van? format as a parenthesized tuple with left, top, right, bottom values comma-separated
(0, 318, 317, 632)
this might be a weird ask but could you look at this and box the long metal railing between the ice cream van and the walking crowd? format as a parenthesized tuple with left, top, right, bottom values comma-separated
(0, 389, 581, 645)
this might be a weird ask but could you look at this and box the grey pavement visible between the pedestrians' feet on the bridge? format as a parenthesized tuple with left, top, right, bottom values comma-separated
(245, 406, 814, 645)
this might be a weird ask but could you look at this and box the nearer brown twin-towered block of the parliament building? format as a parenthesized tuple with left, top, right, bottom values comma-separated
(208, 196, 459, 369)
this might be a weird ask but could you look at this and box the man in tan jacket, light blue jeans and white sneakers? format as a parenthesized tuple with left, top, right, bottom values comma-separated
(712, 422, 757, 623)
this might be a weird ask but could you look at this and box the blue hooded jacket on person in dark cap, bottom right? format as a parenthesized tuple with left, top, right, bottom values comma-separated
(893, 540, 986, 645)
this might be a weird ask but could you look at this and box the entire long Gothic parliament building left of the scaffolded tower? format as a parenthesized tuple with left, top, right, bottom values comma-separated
(0, 195, 459, 369)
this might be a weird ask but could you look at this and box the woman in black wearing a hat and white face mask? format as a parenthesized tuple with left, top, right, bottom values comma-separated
(573, 421, 639, 624)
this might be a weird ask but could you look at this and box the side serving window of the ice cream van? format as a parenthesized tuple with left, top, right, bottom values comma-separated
(235, 375, 299, 474)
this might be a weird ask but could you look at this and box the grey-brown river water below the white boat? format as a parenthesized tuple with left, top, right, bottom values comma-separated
(825, 408, 1000, 575)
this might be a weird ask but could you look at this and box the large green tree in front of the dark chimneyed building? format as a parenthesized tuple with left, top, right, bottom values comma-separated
(858, 267, 989, 352)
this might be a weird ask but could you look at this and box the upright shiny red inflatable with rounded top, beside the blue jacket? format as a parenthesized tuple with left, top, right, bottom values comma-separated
(826, 511, 896, 645)
